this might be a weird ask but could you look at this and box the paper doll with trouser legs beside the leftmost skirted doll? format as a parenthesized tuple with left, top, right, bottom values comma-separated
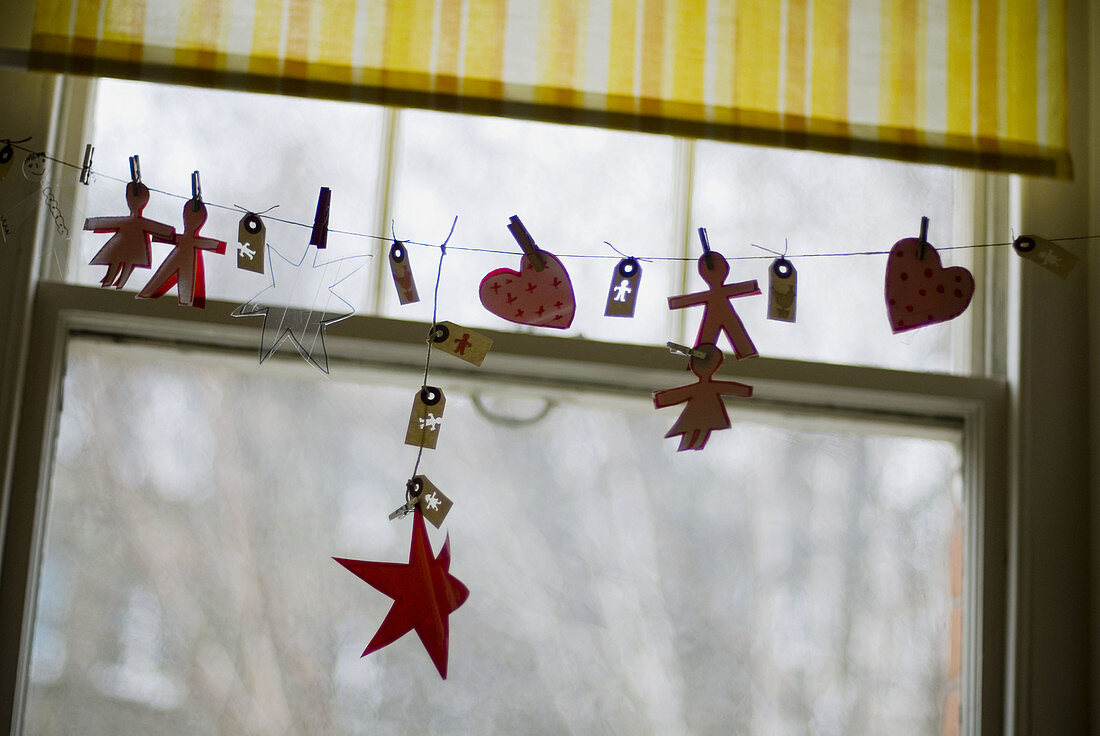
(138, 199, 226, 309)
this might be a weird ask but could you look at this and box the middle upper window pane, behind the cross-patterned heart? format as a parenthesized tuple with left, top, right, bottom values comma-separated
(382, 110, 683, 344)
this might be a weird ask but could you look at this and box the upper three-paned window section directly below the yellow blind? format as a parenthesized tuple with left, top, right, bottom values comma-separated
(55, 79, 985, 374)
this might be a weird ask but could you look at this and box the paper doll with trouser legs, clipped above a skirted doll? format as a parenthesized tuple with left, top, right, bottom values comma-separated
(669, 251, 760, 358)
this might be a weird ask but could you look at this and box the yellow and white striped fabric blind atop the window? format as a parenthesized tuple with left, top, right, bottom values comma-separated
(31, 0, 1071, 177)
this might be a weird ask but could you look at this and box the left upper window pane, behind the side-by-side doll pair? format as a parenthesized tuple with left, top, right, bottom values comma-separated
(65, 79, 383, 309)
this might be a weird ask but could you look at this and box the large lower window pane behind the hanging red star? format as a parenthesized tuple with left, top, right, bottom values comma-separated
(24, 340, 964, 736)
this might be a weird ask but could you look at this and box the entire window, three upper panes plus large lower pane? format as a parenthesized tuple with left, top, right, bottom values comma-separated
(2, 71, 1005, 734)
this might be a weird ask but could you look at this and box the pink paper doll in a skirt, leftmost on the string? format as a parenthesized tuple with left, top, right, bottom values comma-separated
(84, 182, 175, 288)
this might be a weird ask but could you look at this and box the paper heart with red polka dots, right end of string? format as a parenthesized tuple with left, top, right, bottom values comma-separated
(886, 238, 974, 334)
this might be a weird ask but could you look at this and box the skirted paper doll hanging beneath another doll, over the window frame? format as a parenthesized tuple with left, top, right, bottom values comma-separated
(653, 343, 752, 452)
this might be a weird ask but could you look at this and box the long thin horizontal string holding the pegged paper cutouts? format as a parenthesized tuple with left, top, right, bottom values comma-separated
(8, 139, 1100, 263)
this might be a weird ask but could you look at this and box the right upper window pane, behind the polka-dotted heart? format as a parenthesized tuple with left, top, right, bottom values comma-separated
(689, 141, 982, 371)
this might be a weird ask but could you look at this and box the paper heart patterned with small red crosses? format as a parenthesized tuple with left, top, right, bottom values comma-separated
(477, 251, 576, 330)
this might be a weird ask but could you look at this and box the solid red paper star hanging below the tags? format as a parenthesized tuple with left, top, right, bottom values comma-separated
(332, 508, 470, 680)
